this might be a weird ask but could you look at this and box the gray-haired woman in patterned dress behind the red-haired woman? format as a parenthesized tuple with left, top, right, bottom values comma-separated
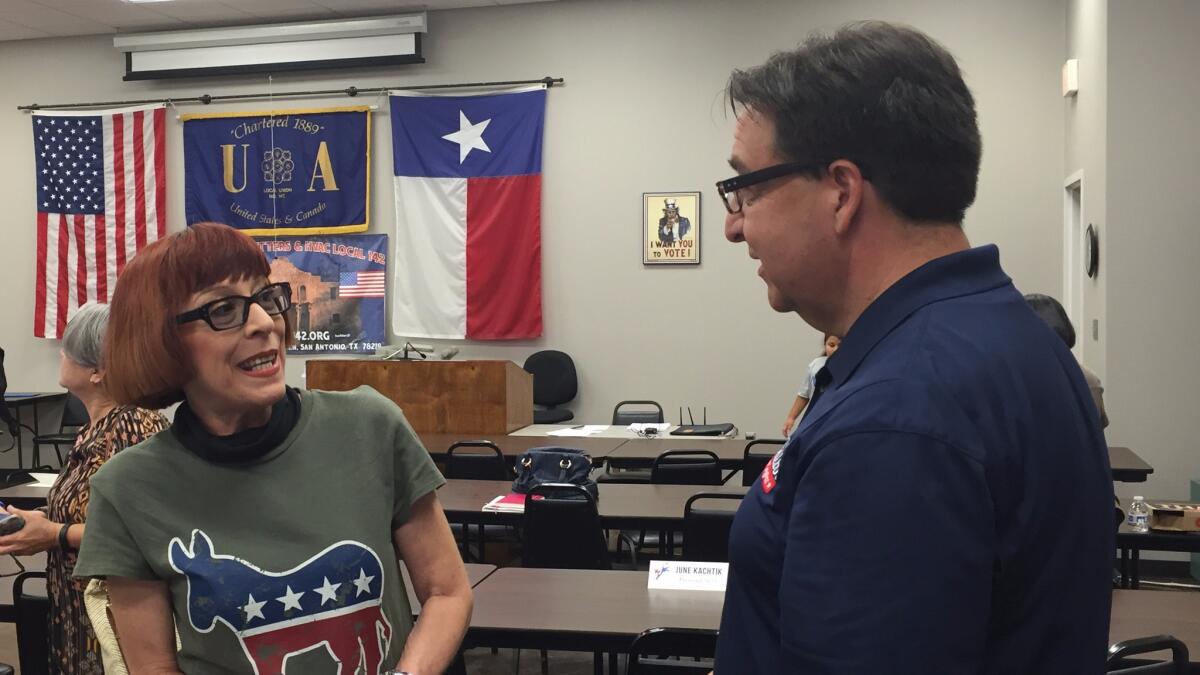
(0, 303, 167, 675)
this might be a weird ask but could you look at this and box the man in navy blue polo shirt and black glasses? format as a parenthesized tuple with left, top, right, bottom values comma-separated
(716, 22, 1114, 675)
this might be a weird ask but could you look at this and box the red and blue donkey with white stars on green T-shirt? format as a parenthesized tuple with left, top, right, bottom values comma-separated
(168, 530, 391, 675)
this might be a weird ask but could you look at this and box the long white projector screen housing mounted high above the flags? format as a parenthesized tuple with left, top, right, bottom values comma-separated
(113, 12, 426, 80)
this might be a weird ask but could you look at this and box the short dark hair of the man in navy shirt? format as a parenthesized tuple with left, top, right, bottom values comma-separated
(727, 22, 982, 225)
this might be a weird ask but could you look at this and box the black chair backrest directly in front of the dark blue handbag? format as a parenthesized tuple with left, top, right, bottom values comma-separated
(522, 483, 610, 569)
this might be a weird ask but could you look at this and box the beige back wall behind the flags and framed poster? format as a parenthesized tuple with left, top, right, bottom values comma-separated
(0, 0, 1067, 432)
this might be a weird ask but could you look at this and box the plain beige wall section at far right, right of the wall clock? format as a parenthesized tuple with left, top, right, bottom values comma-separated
(1104, 0, 1200, 498)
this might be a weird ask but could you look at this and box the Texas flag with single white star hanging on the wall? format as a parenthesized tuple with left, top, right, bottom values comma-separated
(391, 86, 546, 340)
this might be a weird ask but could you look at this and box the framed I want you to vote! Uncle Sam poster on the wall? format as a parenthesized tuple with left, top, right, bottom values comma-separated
(642, 192, 700, 265)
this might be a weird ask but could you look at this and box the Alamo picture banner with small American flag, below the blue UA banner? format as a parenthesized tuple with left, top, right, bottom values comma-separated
(256, 234, 388, 354)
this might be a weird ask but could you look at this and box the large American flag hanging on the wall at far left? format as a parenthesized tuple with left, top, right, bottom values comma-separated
(34, 106, 167, 338)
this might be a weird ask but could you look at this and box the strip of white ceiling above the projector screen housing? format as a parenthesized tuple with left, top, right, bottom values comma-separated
(0, 0, 551, 41)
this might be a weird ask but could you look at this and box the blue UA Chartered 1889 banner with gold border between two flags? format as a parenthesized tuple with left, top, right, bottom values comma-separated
(182, 107, 371, 235)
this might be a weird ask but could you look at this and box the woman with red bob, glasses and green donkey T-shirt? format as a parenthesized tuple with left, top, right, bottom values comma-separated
(76, 223, 472, 674)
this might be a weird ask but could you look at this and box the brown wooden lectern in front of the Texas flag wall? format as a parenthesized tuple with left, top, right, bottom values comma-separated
(307, 359, 533, 434)
